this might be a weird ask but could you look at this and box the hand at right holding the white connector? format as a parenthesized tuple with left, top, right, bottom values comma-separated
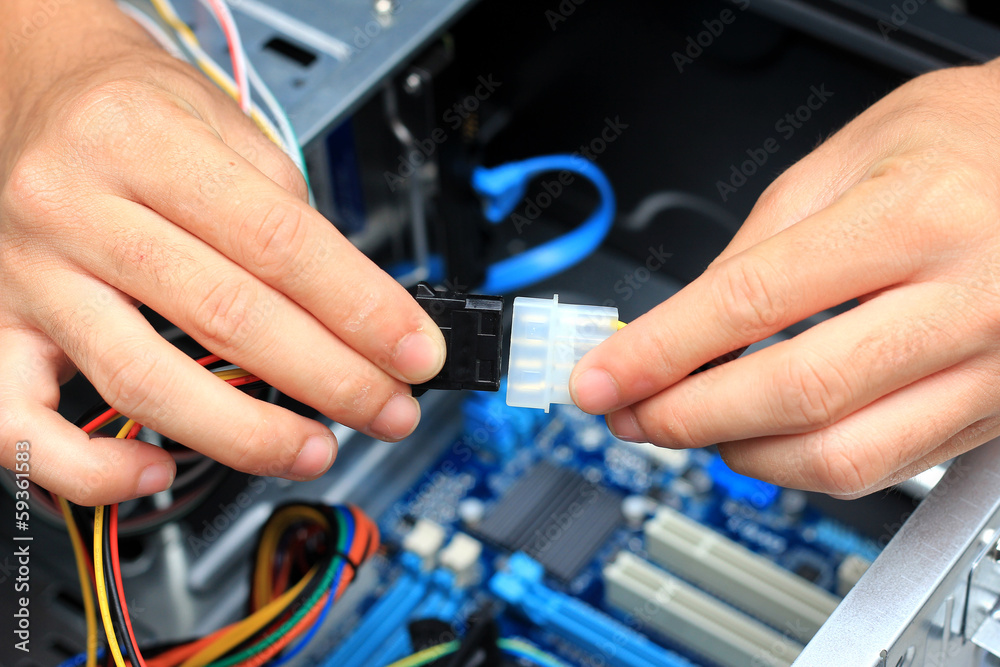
(571, 62, 1000, 496)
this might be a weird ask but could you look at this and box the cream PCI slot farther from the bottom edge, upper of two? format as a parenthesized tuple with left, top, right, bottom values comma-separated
(645, 507, 840, 643)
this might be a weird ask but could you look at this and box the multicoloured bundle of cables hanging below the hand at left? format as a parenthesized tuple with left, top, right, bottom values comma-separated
(53, 355, 379, 667)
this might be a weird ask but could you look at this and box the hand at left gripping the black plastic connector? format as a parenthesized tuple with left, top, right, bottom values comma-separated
(0, 0, 445, 504)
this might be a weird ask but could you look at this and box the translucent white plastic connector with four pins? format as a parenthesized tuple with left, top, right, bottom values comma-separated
(507, 294, 619, 412)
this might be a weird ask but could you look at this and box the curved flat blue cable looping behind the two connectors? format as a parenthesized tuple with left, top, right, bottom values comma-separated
(472, 155, 615, 294)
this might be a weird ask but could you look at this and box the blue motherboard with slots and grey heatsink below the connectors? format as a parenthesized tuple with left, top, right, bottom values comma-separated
(308, 392, 879, 667)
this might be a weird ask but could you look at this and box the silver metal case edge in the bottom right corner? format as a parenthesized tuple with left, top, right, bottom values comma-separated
(795, 440, 1000, 667)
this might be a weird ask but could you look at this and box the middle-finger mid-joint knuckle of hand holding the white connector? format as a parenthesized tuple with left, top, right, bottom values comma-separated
(775, 352, 851, 428)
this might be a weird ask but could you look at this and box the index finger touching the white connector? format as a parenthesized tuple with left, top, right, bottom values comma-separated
(570, 175, 919, 414)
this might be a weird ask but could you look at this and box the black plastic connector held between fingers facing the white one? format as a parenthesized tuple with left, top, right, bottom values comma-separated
(413, 283, 503, 396)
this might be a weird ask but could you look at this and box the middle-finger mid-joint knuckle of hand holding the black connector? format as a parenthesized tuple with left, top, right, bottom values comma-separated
(192, 278, 259, 350)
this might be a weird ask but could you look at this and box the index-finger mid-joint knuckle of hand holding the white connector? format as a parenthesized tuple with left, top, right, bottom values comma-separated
(713, 257, 788, 341)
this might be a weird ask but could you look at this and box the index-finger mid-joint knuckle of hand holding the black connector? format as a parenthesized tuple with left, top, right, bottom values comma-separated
(246, 200, 306, 278)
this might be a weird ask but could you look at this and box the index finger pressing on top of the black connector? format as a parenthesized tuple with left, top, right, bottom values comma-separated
(103, 114, 445, 383)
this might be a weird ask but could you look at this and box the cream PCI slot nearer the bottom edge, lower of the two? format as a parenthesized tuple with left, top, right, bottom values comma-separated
(604, 551, 802, 667)
